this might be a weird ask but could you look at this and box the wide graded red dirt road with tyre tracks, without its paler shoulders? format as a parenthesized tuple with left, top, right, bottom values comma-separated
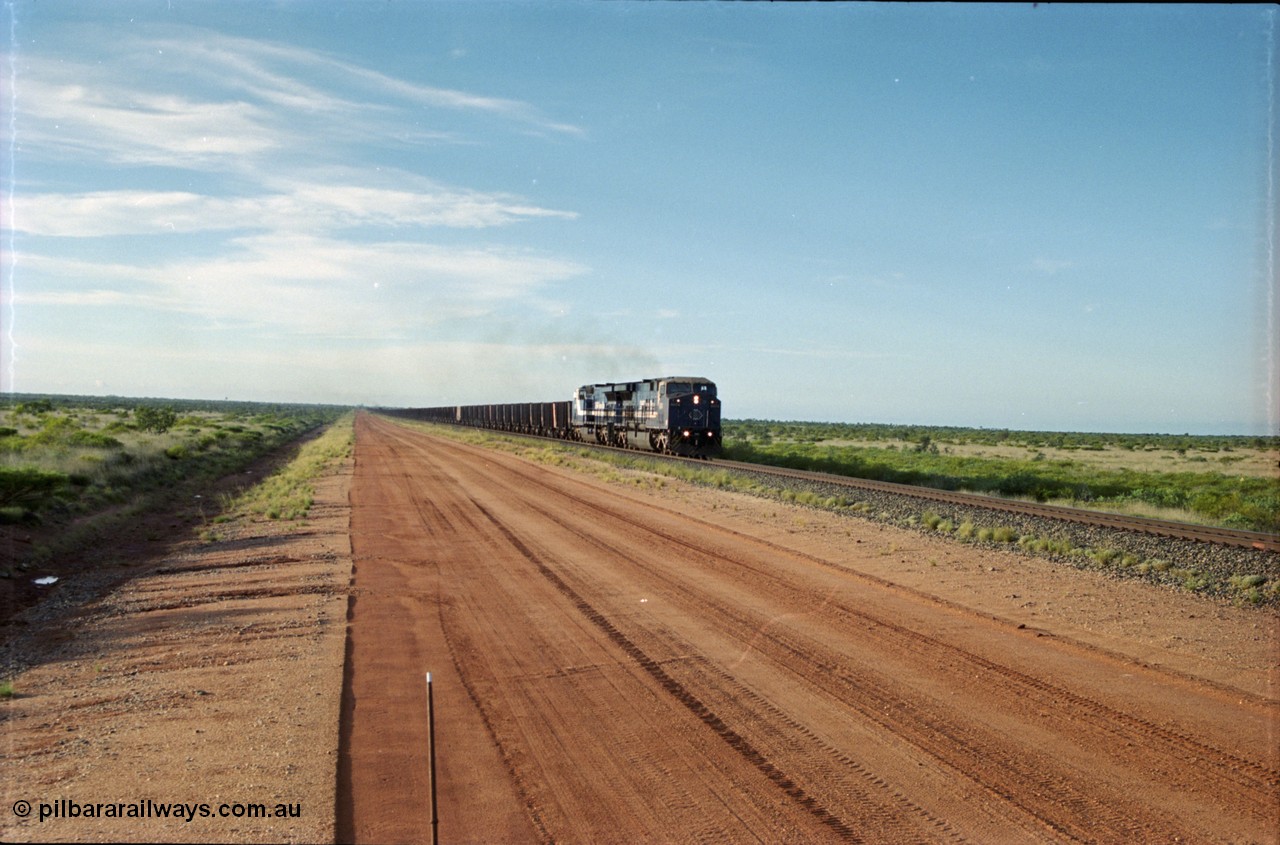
(337, 415, 1280, 842)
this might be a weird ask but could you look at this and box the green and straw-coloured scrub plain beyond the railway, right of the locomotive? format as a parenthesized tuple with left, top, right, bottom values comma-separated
(724, 420, 1280, 531)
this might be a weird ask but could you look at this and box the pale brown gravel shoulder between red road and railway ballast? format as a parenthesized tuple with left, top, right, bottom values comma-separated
(666, 476, 1280, 705)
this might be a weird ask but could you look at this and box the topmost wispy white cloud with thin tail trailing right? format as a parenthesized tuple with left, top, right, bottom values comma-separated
(10, 28, 582, 172)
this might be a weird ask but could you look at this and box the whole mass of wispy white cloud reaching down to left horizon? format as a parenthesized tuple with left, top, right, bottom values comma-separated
(0, 18, 608, 401)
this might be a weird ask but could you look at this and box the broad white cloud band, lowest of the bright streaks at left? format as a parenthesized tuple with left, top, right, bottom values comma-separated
(15, 233, 585, 338)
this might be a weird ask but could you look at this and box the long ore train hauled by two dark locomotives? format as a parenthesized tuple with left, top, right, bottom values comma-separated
(387, 375, 721, 457)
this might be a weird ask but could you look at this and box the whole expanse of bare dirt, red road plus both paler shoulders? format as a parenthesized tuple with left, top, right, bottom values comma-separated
(0, 415, 1280, 844)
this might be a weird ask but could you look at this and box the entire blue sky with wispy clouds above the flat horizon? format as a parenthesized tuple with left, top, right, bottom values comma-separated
(0, 0, 1280, 434)
